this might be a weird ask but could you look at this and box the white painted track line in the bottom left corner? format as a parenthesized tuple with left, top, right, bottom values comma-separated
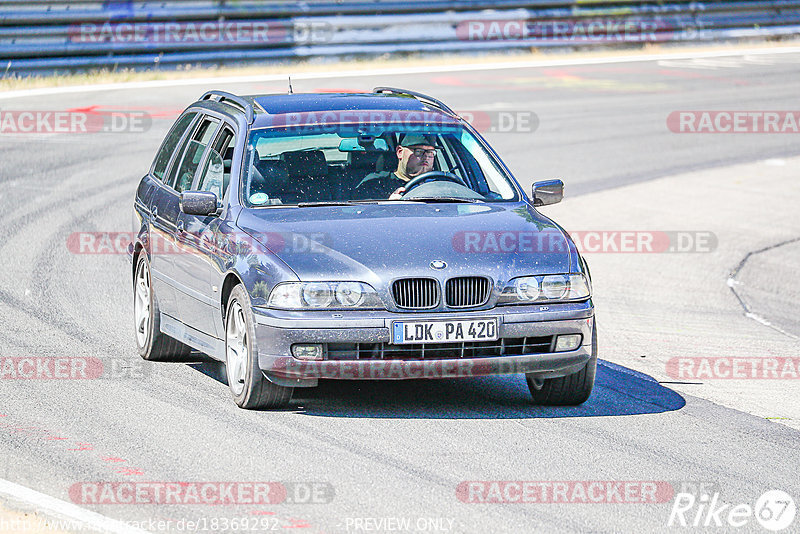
(0, 479, 146, 534)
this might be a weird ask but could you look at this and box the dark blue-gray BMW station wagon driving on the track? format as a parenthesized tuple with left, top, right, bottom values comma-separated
(128, 87, 597, 408)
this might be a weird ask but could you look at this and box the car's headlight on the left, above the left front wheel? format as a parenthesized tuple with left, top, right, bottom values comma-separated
(267, 282, 383, 310)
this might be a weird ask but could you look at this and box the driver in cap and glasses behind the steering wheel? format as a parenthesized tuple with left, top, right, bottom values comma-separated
(358, 134, 436, 200)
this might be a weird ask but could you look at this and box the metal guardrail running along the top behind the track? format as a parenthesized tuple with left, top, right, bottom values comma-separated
(0, 0, 800, 75)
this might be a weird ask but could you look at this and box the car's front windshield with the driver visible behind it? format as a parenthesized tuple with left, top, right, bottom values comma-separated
(243, 126, 518, 207)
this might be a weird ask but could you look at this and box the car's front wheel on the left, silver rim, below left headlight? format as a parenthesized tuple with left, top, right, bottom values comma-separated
(225, 284, 294, 410)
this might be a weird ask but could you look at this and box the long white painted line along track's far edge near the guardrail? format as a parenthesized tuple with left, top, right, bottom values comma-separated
(0, 47, 800, 100)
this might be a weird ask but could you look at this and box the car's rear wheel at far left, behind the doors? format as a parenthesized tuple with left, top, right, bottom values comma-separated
(133, 251, 192, 362)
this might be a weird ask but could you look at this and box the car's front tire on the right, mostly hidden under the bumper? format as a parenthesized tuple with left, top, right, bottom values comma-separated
(525, 323, 597, 406)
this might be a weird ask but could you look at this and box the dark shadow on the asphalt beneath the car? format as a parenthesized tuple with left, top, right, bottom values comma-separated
(191, 360, 686, 419)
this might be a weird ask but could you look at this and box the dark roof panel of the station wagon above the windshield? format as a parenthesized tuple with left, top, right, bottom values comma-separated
(243, 93, 457, 128)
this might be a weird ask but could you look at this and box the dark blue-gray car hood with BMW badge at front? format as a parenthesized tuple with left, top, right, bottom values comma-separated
(238, 203, 574, 284)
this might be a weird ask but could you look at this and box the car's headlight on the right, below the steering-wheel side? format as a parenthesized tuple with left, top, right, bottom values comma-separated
(498, 274, 592, 304)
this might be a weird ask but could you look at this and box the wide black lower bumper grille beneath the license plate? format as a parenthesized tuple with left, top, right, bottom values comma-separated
(325, 336, 553, 360)
